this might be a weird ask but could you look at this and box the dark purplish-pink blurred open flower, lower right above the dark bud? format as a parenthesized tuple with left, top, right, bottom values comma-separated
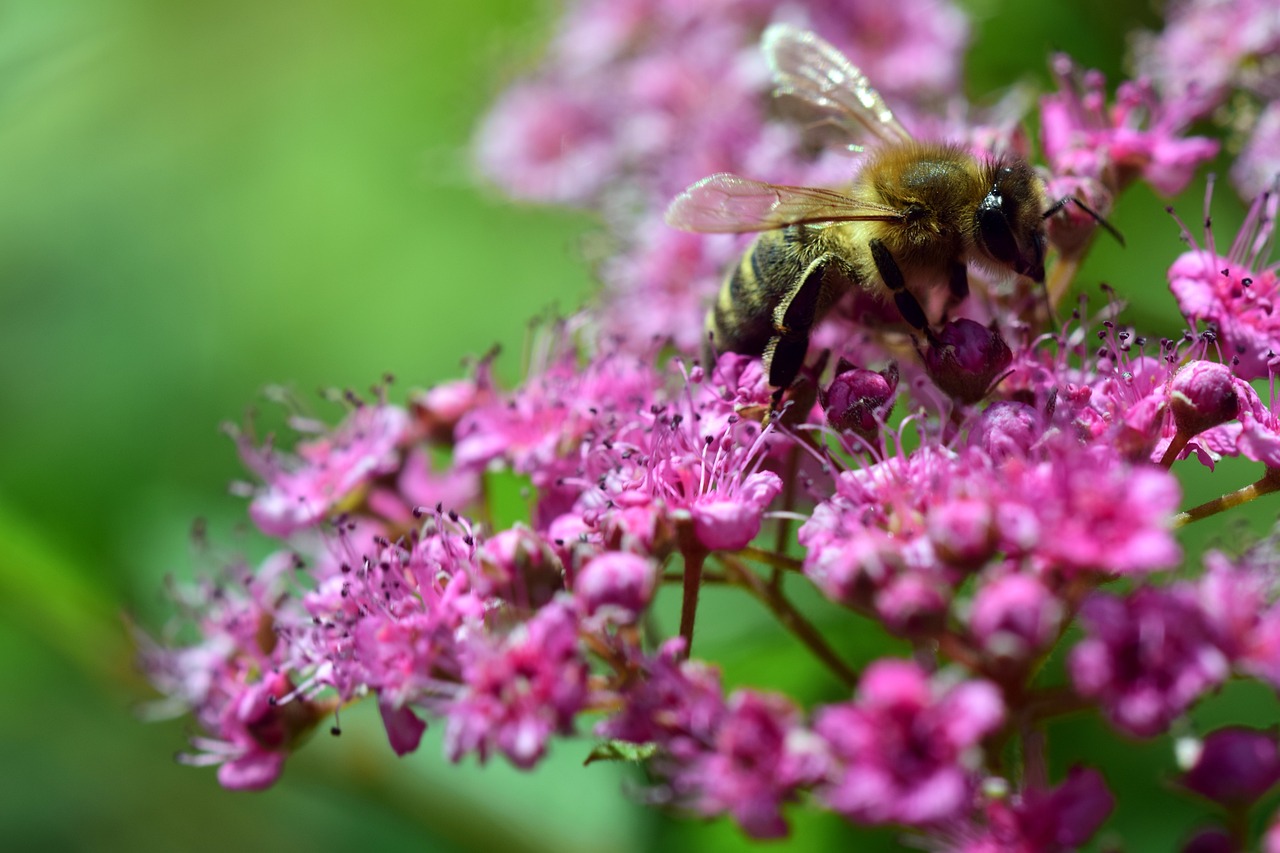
(1069, 587, 1230, 738)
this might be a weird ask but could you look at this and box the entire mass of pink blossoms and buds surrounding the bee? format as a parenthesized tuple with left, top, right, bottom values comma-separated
(140, 0, 1280, 853)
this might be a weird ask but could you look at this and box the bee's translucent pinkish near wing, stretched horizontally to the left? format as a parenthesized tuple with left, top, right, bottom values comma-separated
(667, 172, 902, 234)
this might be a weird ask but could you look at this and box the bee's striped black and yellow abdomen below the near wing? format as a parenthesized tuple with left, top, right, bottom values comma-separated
(707, 227, 805, 355)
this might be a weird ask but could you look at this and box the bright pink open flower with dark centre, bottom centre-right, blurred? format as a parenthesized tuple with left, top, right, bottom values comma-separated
(814, 660, 1005, 826)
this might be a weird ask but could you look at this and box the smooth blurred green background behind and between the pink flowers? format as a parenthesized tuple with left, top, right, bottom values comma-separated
(0, 0, 1275, 853)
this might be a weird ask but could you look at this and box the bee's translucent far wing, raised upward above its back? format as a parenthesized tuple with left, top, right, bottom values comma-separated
(760, 24, 911, 149)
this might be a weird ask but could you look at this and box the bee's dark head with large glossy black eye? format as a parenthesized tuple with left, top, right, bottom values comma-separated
(974, 160, 1044, 282)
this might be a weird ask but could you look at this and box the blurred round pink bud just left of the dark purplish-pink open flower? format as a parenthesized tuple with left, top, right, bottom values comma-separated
(969, 575, 1062, 661)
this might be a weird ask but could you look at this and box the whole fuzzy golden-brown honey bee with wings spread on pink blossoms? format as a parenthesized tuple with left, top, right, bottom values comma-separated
(667, 24, 1049, 396)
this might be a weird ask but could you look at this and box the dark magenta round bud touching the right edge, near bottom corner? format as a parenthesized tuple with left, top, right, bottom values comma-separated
(1181, 726, 1280, 807)
